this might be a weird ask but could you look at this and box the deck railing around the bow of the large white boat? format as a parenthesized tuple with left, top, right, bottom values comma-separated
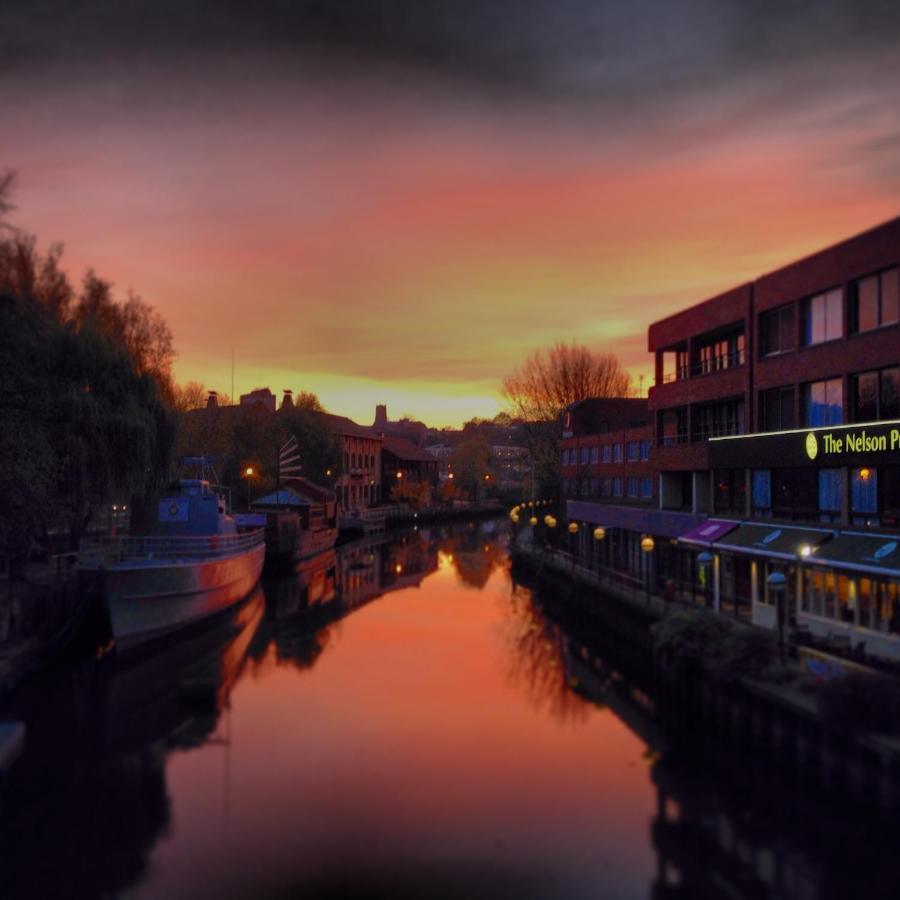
(79, 528, 265, 568)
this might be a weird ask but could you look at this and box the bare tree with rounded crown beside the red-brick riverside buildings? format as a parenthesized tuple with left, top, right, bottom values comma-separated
(501, 341, 631, 490)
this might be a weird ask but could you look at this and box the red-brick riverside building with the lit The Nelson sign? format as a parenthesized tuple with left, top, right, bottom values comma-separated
(562, 218, 900, 658)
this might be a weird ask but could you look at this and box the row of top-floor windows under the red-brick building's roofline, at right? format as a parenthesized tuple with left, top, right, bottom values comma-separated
(759, 266, 900, 356)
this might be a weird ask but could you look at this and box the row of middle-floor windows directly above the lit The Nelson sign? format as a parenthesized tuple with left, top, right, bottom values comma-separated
(759, 366, 900, 431)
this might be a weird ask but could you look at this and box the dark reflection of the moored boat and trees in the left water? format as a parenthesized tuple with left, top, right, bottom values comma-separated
(0, 592, 263, 898)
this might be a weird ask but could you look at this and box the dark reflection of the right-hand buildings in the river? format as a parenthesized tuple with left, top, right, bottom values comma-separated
(526, 584, 900, 900)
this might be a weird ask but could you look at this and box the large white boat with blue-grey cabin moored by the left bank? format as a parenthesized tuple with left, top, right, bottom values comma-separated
(79, 478, 266, 651)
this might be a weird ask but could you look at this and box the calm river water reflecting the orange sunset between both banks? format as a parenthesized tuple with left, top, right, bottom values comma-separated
(0, 523, 900, 898)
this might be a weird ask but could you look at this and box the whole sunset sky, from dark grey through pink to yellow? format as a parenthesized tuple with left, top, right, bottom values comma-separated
(0, 0, 900, 426)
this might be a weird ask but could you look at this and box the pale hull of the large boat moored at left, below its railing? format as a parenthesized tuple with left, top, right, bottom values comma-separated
(103, 543, 265, 651)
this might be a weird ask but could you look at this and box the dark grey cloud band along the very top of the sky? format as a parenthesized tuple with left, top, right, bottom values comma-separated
(7, 0, 900, 103)
